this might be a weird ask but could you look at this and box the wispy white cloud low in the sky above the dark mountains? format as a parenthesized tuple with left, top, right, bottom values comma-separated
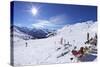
(32, 15, 66, 28)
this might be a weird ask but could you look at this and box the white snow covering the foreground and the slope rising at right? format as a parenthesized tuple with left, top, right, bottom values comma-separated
(13, 21, 97, 66)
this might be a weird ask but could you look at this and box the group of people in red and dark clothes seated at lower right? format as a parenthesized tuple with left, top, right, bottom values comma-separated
(72, 33, 97, 59)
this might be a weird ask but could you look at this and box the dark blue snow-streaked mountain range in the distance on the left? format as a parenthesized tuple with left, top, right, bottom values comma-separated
(13, 25, 53, 39)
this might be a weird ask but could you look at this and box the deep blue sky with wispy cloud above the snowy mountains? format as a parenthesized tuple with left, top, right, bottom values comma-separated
(13, 1, 97, 29)
